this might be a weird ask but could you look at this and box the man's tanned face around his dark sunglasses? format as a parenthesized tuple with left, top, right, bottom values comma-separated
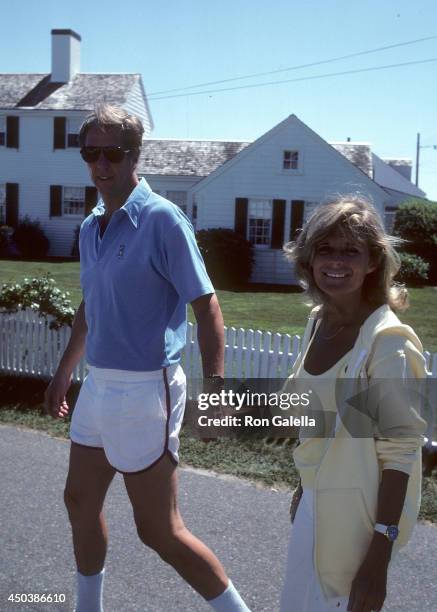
(85, 127, 136, 197)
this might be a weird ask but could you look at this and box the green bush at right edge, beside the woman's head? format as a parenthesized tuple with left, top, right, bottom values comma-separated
(393, 200, 437, 284)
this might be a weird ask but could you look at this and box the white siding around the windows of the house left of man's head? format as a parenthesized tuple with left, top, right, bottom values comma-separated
(0, 113, 92, 257)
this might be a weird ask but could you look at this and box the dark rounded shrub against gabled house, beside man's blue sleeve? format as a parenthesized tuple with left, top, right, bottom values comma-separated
(196, 228, 253, 289)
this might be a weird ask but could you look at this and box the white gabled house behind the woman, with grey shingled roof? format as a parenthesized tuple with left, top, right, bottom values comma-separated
(139, 115, 425, 284)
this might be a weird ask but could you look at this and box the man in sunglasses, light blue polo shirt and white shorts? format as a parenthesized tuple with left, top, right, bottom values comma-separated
(45, 105, 248, 612)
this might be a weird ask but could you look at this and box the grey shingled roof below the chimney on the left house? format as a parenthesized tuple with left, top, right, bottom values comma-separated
(0, 73, 141, 110)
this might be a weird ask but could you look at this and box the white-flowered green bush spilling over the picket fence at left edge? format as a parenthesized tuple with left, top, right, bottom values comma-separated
(0, 274, 74, 329)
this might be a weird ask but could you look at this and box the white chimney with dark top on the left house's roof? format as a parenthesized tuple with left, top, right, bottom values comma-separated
(51, 30, 82, 83)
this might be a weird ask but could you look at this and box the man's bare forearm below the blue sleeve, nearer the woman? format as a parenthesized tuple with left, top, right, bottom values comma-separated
(191, 293, 225, 378)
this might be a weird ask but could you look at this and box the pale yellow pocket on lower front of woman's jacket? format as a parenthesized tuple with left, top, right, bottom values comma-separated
(315, 488, 374, 596)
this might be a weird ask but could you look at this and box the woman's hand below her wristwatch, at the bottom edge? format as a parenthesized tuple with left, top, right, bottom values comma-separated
(347, 533, 392, 612)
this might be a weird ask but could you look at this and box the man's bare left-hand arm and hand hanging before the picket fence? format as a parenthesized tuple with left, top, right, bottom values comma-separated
(44, 300, 87, 418)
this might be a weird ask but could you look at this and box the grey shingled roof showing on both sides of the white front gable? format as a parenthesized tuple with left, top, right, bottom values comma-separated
(138, 139, 372, 177)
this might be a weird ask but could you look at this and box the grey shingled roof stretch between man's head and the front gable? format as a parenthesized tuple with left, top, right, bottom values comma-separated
(138, 138, 250, 176)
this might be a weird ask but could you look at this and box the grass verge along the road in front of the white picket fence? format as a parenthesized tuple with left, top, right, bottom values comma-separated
(0, 376, 437, 523)
